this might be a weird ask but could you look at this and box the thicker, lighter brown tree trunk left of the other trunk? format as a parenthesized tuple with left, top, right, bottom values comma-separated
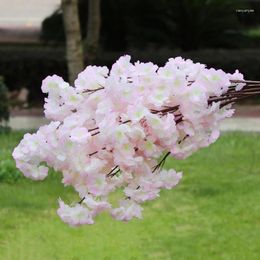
(61, 0, 84, 84)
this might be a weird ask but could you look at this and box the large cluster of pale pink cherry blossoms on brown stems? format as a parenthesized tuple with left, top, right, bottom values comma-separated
(13, 56, 244, 226)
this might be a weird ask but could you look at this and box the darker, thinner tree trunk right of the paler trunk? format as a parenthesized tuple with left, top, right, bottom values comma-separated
(85, 0, 101, 64)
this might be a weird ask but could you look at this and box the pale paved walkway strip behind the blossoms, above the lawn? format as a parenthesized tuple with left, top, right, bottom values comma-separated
(10, 116, 260, 132)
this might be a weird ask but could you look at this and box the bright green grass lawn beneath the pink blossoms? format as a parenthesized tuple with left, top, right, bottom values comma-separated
(0, 133, 260, 260)
